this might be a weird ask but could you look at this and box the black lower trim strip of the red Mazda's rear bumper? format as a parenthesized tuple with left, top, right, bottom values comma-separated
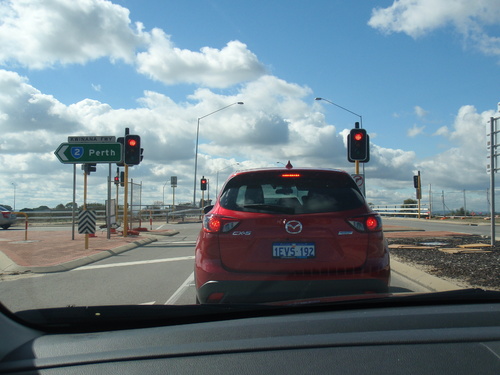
(196, 276, 389, 303)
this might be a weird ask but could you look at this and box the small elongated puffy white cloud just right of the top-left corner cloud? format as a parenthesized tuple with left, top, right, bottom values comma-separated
(137, 29, 265, 88)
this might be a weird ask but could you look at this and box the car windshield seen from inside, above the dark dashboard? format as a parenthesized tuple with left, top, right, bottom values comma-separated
(0, 0, 500, 322)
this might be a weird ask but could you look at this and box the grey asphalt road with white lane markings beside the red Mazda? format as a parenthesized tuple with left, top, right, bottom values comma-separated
(0, 223, 426, 311)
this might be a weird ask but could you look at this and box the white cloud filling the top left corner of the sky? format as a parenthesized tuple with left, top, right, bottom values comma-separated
(0, 0, 148, 69)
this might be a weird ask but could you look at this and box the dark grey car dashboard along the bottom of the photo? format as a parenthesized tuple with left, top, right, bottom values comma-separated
(0, 303, 500, 375)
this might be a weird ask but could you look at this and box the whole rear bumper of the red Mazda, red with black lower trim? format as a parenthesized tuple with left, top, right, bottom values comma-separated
(195, 241, 391, 303)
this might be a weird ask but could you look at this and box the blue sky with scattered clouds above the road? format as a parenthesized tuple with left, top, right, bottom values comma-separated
(0, 0, 500, 210)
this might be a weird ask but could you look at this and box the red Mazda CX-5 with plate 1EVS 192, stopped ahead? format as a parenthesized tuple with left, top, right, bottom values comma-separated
(195, 168, 390, 303)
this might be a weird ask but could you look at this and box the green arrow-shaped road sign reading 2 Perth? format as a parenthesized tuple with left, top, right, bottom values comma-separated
(54, 142, 122, 164)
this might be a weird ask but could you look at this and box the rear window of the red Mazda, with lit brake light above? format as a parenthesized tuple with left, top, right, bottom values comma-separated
(220, 171, 364, 214)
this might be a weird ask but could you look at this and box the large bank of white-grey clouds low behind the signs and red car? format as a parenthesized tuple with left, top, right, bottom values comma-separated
(0, 64, 494, 207)
